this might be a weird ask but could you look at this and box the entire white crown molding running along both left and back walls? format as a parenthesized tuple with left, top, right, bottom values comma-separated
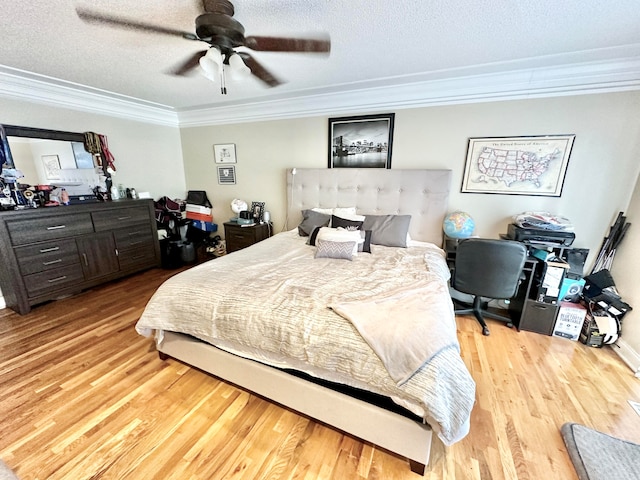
(0, 56, 640, 127)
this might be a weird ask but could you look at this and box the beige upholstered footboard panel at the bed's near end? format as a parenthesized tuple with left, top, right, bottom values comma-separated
(158, 331, 433, 475)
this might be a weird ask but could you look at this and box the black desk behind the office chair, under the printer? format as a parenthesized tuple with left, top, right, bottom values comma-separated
(443, 236, 589, 335)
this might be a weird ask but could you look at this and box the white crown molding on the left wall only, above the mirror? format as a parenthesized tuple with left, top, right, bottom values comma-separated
(0, 65, 178, 127)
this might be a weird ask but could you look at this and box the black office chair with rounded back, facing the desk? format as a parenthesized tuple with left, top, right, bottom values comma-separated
(451, 238, 527, 335)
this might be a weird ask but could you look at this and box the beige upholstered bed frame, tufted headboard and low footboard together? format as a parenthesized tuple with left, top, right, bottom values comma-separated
(158, 168, 451, 475)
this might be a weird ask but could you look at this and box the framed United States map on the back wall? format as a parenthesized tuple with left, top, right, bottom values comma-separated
(461, 135, 575, 197)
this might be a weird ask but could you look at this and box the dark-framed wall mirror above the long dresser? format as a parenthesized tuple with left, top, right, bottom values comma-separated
(4, 125, 104, 195)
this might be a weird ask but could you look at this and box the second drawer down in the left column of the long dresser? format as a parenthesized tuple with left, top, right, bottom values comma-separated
(14, 238, 80, 275)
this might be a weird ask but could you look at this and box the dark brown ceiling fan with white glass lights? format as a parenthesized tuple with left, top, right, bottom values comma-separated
(76, 0, 331, 94)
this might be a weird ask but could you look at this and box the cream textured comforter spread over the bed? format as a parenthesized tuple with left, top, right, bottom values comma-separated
(136, 231, 475, 445)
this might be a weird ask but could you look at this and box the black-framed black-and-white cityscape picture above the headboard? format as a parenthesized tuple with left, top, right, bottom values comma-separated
(329, 113, 395, 168)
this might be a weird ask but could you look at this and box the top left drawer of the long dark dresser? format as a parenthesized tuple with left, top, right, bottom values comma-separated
(7, 213, 93, 245)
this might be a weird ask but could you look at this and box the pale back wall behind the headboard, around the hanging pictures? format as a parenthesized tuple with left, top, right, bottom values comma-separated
(181, 92, 640, 264)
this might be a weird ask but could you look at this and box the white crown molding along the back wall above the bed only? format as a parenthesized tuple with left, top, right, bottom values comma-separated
(178, 58, 640, 127)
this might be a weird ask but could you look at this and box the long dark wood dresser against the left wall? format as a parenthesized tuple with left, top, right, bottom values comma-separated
(0, 200, 160, 314)
